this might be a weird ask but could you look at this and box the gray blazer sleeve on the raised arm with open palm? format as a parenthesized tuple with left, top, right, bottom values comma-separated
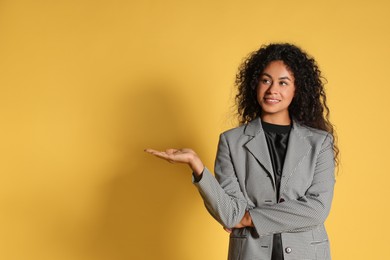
(194, 134, 247, 228)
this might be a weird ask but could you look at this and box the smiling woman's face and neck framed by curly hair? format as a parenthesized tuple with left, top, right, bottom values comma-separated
(257, 60, 295, 125)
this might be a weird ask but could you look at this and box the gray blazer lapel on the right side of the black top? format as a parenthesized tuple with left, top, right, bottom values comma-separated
(280, 121, 312, 197)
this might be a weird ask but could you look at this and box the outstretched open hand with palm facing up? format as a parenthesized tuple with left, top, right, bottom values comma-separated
(145, 148, 204, 175)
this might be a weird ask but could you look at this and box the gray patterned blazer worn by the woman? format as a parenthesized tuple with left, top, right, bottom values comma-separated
(194, 118, 335, 260)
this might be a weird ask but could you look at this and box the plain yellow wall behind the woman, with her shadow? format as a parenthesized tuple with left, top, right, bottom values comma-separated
(0, 0, 390, 260)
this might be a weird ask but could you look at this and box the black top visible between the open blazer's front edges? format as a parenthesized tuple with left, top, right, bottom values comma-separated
(261, 121, 291, 260)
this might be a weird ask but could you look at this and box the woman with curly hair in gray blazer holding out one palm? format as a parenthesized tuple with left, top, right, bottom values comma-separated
(146, 44, 338, 260)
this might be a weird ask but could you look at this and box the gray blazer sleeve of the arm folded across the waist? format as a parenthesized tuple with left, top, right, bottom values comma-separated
(249, 134, 335, 236)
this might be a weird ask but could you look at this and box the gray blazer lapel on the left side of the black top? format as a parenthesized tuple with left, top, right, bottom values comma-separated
(245, 118, 275, 187)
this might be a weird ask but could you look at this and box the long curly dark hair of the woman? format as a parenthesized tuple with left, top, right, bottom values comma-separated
(235, 43, 339, 163)
